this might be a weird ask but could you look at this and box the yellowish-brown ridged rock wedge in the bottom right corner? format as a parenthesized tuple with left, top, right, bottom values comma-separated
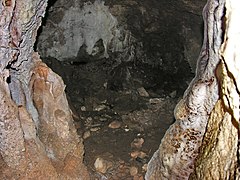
(190, 100, 238, 180)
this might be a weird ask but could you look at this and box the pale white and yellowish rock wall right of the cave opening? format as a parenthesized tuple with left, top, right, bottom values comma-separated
(146, 0, 240, 180)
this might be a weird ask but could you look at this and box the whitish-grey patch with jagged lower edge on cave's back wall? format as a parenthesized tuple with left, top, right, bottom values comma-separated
(38, 0, 127, 61)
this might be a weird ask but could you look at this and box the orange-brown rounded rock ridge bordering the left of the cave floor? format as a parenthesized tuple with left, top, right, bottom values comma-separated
(29, 54, 87, 179)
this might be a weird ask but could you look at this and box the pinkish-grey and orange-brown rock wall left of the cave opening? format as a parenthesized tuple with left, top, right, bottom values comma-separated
(0, 0, 88, 179)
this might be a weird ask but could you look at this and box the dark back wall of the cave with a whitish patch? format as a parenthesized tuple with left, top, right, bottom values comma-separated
(36, 0, 206, 73)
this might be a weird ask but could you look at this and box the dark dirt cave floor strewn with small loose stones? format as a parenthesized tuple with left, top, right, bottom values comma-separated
(47, 60, 188, 180)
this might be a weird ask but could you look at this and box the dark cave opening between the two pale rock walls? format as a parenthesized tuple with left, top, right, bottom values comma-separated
(35, 0, 206, 179)
